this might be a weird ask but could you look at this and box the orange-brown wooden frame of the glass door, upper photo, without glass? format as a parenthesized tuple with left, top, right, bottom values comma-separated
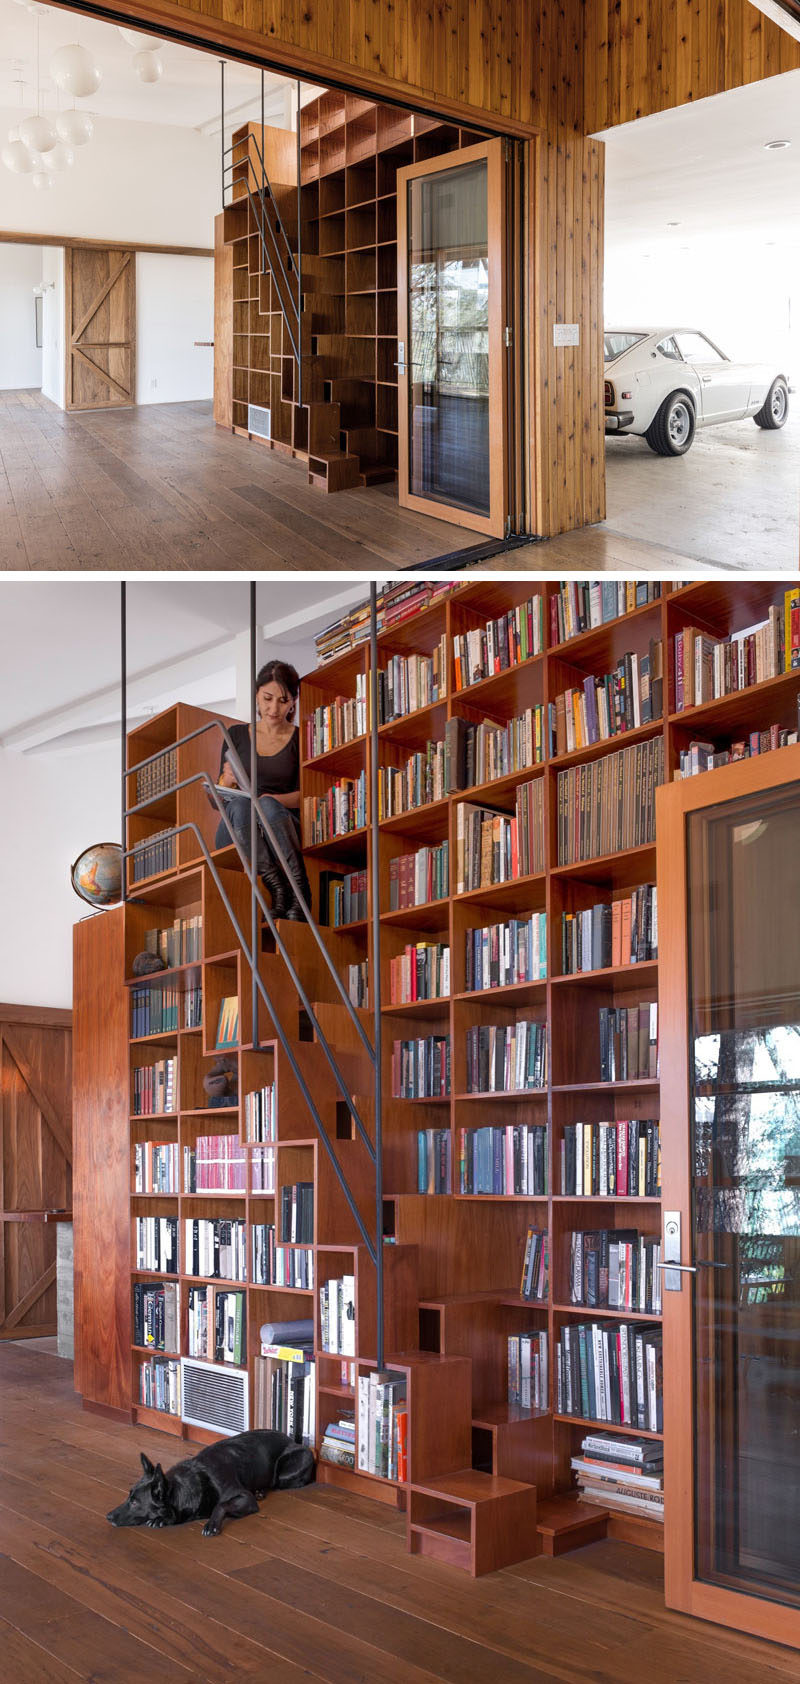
(397, 136, 510, 537)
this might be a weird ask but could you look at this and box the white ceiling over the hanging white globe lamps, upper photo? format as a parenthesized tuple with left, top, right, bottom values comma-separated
(0, 0, 313, 140)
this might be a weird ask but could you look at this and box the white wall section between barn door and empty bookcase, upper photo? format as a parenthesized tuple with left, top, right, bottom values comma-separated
(136, 251, 214, 404)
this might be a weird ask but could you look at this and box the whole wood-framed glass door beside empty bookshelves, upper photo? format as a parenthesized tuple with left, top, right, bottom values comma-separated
(397, 140, 507, 537)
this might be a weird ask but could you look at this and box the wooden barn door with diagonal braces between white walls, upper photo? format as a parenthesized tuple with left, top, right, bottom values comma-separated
(66, 246, 136, 409)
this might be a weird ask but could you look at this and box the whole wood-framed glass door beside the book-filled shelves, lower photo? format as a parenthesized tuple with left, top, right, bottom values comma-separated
(659, 749, 800, 1644)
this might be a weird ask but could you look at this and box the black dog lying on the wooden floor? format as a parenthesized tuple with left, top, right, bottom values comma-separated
(106, 1431, 315, 1537)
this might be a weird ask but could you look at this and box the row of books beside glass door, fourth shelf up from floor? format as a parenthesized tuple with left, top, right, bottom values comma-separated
(561, 1116, 662, 1199)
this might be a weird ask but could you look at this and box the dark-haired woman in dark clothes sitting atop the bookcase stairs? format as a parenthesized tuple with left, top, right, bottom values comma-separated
(216, 660, 310, 918)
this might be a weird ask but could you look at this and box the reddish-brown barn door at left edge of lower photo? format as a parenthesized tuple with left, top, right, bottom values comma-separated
(0, 1005, 72, 1339)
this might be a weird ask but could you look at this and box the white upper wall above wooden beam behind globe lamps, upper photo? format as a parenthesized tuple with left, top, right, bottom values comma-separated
(0, 109, 221, 248)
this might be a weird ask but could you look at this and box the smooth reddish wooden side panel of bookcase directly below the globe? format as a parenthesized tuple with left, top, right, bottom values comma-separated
(72, 906, 131, 1413)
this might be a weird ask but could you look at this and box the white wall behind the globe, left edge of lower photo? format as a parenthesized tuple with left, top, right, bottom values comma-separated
(0, 743, 120, 1007)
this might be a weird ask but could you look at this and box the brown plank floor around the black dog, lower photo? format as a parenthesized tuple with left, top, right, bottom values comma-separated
(0, 1344, 797, 1684)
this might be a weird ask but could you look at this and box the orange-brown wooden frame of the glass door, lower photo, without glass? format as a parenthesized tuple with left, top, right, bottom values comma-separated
(655, 743, 800, 1649)
